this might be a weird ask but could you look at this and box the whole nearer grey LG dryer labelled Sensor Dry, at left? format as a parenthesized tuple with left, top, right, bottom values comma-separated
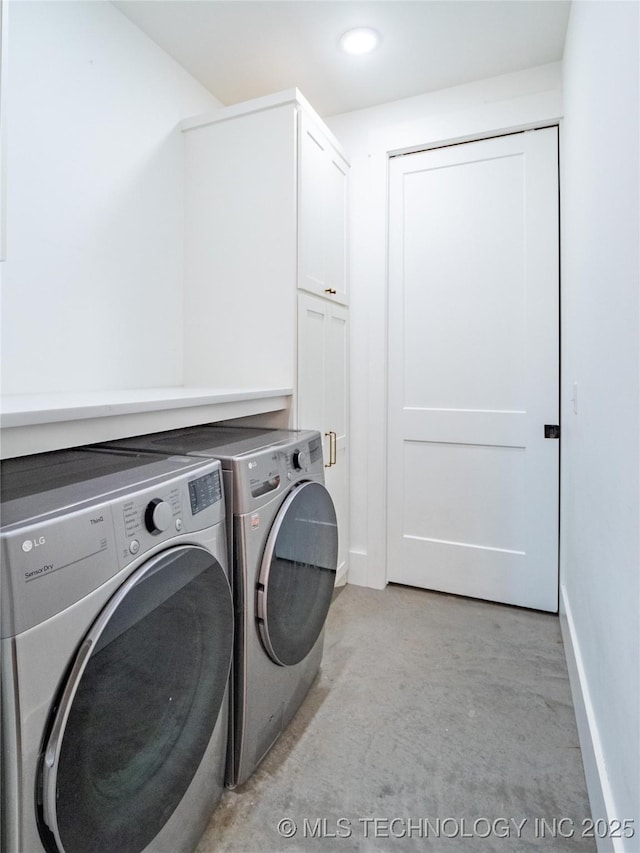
(0, 449, 233, 853)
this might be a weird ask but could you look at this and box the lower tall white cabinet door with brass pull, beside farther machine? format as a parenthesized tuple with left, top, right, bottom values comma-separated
(297, 293, 349, 583)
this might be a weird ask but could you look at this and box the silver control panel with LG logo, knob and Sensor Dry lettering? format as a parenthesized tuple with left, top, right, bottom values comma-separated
(0, 455, 225, 637)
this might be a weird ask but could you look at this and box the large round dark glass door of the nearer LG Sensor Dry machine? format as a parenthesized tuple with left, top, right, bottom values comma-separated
(41, 546, 233, 853)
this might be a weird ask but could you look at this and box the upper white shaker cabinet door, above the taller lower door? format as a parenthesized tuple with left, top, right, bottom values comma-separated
(298, 113, 349, 304)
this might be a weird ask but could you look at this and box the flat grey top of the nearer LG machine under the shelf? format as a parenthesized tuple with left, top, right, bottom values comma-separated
(0, 448, 218, 530)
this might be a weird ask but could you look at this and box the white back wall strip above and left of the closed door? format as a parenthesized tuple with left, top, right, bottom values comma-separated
(327, 63, 562, 588)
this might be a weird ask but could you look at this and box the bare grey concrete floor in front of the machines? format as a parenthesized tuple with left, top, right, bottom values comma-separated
(197, 586, 596, 853)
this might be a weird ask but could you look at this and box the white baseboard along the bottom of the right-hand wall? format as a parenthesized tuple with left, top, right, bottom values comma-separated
(560, 585, 638, 853)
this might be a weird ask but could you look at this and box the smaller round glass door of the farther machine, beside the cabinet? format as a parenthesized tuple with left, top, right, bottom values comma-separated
(258, 483, 338, 666)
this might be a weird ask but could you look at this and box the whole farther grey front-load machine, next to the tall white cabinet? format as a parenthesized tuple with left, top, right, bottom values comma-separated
(97, 425, 338, 787)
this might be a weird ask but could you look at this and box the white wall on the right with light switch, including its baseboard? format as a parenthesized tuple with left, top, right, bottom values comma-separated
(561, 2, 640, 853)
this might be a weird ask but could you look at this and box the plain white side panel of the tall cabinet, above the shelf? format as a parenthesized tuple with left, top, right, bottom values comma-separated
(183, 98, 297, 388)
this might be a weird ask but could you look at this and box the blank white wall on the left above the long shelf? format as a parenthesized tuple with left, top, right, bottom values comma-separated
(2, 0, 220, 394)
